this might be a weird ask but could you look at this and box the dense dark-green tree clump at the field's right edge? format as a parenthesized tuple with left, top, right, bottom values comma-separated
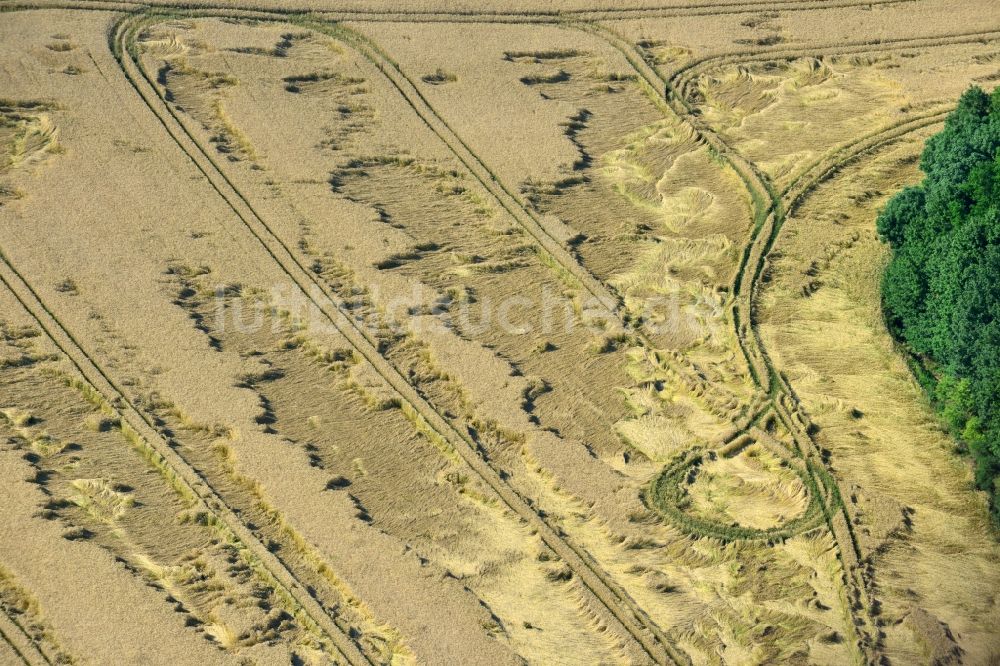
(878, 87, 1000, 519)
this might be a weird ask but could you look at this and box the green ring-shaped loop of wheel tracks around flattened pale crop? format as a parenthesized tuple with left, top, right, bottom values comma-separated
(645, 450, 840, 542)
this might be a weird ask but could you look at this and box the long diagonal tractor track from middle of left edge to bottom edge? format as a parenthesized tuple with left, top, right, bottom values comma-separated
(0, 195, 370, 665)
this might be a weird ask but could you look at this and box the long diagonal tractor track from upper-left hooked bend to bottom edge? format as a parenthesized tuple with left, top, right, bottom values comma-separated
(109, 12, 688, 663)
